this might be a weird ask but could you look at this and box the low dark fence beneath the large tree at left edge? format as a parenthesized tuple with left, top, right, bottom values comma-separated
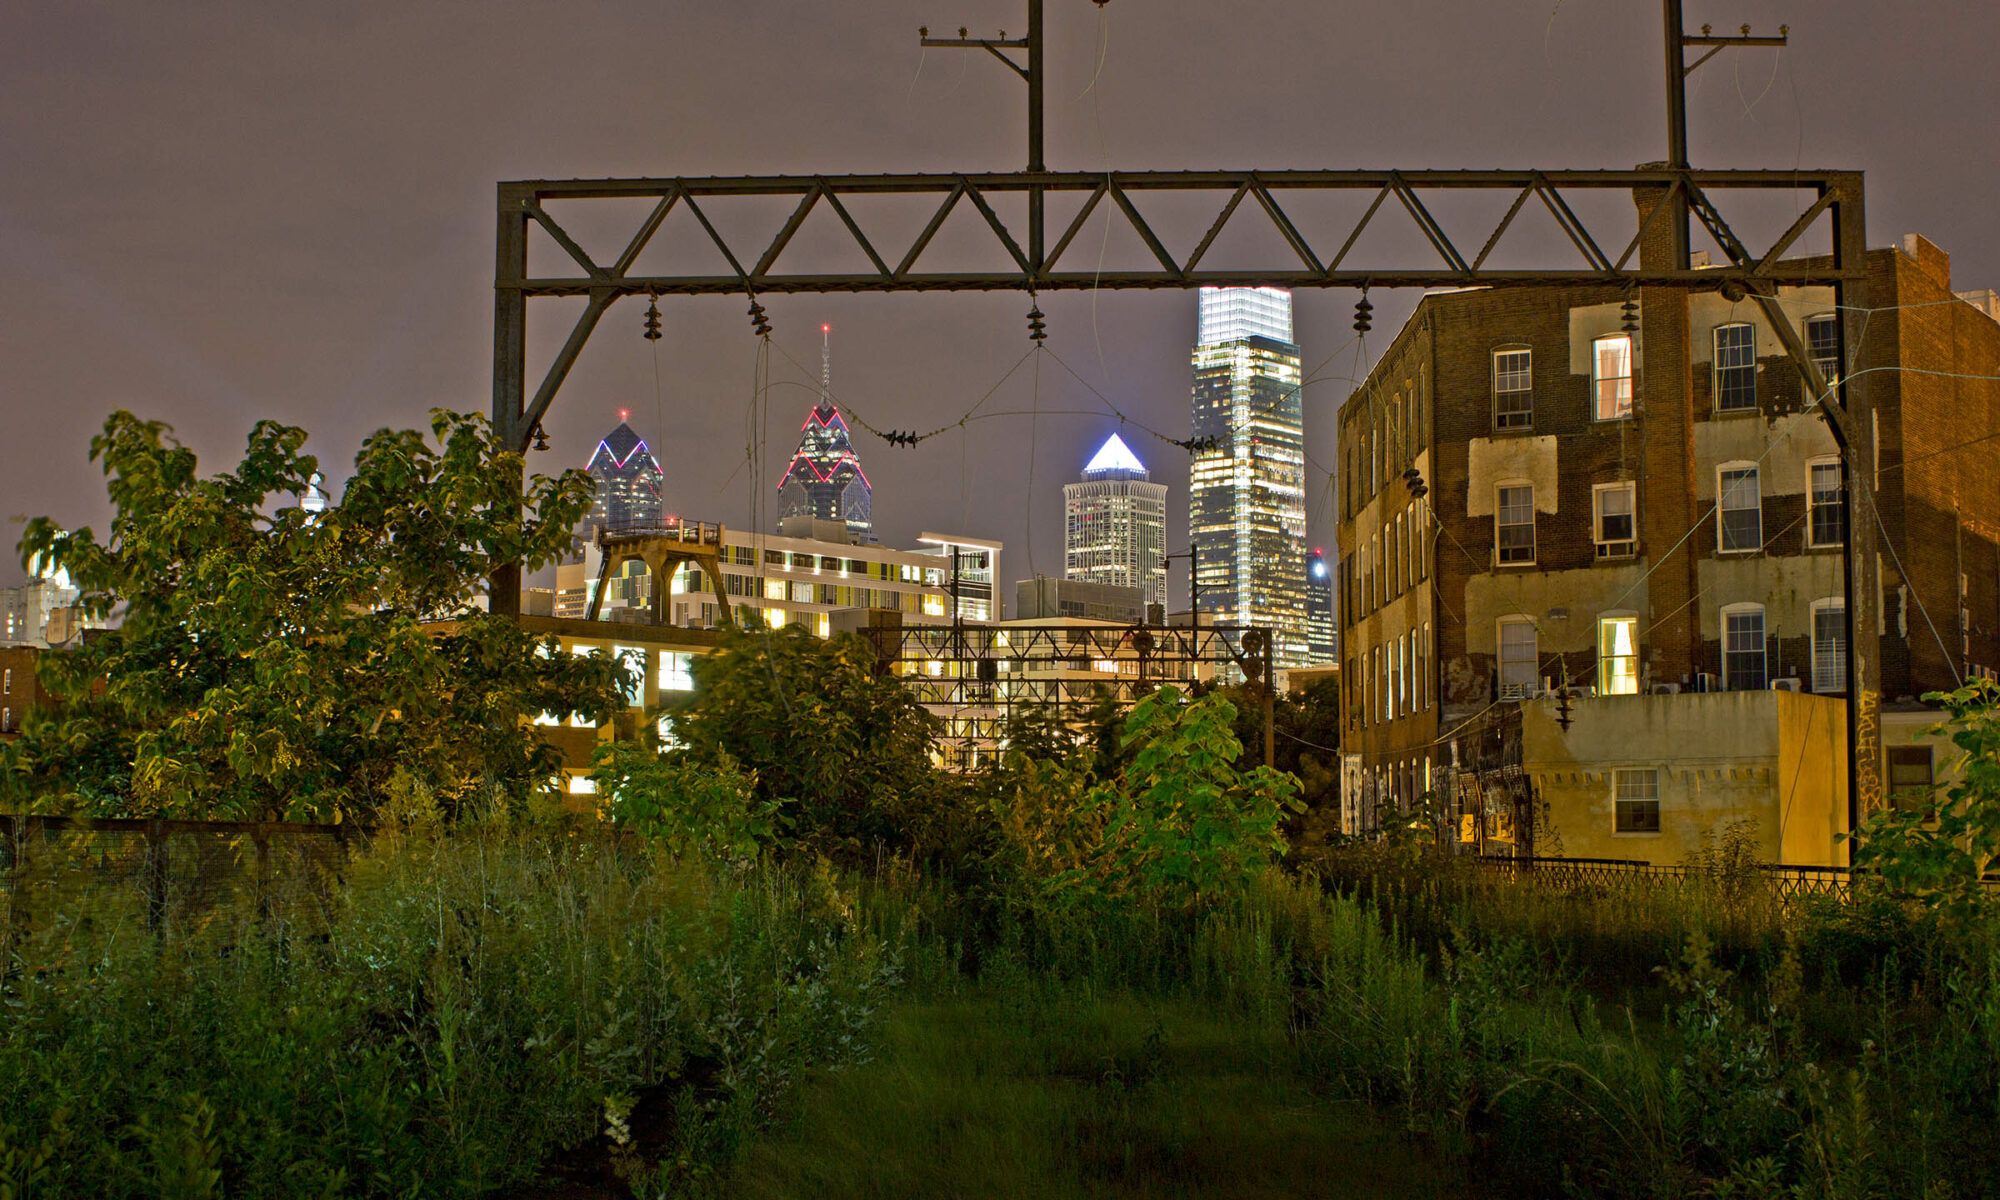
(0, 814, 368, 938)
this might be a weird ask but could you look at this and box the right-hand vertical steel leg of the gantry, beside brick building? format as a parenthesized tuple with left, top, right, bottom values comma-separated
(1832, 190, 1884, 854)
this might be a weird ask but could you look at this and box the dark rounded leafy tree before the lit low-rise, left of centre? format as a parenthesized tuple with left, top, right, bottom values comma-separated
(674, 624, 938, 856)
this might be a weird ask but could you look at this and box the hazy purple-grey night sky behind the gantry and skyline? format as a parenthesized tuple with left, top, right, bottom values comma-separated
(0, 0, 2000, 594)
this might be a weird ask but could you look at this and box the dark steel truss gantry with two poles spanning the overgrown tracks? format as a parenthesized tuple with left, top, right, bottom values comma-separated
(492, 0, 1882, 818)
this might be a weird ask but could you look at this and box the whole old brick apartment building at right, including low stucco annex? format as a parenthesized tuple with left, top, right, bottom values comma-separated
(1338, 196, 2000, 862)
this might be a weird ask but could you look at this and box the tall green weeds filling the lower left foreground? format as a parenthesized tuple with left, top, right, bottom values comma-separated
(0, 830, 898, 1198)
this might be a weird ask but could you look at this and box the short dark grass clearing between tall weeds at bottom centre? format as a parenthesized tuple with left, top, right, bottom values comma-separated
(730, 992, 1444, 1200)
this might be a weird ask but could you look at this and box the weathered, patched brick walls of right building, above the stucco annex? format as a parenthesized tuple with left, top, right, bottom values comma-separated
(1338, 216, 2000, 824)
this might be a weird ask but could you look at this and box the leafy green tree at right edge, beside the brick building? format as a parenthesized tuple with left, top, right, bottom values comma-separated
(1854, 680, 2000, 920)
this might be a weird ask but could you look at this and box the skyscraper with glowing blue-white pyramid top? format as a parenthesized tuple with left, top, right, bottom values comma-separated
(1062, 434, 1166, 604)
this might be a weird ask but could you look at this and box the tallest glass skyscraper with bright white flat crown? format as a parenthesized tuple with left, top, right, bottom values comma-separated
(1188, 288, 1310, 666)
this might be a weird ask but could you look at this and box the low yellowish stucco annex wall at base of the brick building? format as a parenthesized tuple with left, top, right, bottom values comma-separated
(1522, 690, 1848, 864)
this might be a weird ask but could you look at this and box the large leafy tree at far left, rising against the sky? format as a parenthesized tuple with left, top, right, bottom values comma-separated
(0, 410, 620, 820)
